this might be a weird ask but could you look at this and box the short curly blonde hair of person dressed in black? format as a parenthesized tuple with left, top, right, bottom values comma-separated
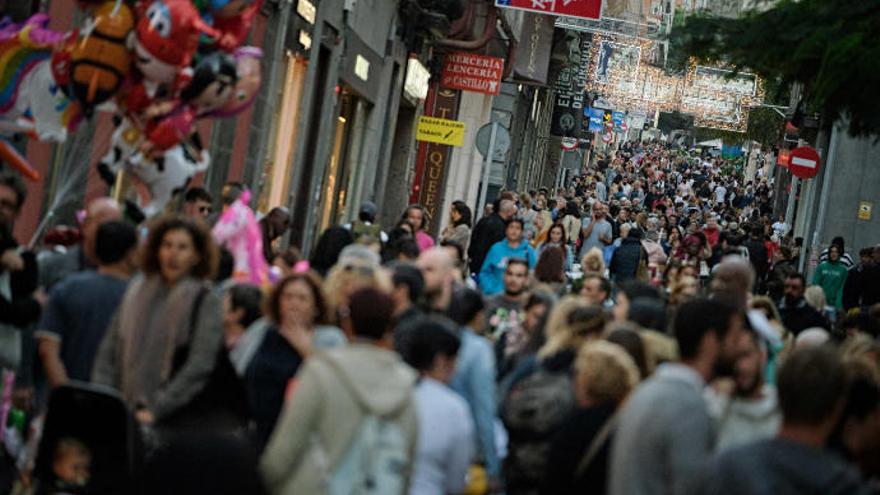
(574, 340, 639, 404)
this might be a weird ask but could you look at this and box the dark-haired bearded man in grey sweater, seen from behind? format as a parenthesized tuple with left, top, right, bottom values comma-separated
(608, 299, 745, 495)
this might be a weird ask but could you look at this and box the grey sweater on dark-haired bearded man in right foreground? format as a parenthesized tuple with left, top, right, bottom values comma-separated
(609, 363, 712, 495)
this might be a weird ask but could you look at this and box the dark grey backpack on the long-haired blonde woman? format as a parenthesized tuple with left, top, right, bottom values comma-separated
(501, 365, 575, 488)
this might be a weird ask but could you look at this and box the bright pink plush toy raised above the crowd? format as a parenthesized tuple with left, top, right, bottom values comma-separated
(212, 191, 269, 286)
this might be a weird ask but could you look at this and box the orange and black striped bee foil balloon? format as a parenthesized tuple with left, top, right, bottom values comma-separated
(69, 1, 134, 109)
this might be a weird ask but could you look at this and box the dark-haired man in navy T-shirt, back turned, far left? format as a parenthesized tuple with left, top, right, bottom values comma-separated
(35, 221, 138, 387)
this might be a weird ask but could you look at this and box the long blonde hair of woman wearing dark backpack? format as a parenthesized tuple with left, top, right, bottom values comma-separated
(538, 296, 606, 359)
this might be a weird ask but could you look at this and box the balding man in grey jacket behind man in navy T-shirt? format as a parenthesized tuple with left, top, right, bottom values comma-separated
(40, 197, 122, 292)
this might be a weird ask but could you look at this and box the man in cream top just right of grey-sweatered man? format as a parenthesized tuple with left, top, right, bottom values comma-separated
(706, 333, 782, 452)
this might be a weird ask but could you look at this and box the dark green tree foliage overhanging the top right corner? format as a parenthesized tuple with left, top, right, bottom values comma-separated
(670, 0, 880, 136)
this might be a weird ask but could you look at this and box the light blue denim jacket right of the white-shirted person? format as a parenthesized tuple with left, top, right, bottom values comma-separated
(450, 327, 501, 477)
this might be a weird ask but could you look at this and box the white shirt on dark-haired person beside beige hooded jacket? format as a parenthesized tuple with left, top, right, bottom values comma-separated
(409, 377, 476, 495)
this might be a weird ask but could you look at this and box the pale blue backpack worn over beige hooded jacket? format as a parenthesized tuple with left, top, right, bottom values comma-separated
(325, 415, 409, 495)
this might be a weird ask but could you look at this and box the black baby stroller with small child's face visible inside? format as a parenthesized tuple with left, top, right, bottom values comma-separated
(33, 382, 141, 495)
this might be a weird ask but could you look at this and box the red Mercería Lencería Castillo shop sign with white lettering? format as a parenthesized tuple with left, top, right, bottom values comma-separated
(440, 52, 504, 95)
